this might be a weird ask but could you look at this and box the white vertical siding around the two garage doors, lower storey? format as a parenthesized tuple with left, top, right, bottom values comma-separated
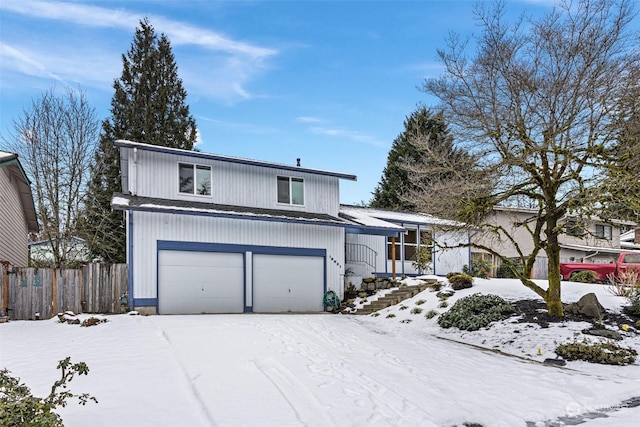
(128, 212, 344, 299)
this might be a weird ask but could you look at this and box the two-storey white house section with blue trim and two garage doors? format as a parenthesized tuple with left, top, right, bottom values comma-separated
(112, 141, 468, 314)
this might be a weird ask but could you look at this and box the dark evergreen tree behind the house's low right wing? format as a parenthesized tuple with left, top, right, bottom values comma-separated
(370, 106, 464, 211)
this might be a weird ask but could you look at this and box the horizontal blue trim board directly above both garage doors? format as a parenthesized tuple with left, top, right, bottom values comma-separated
(157, 240, 327, 257)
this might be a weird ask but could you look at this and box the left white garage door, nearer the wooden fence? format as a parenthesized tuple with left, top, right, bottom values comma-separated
(158, 251, 244, 314)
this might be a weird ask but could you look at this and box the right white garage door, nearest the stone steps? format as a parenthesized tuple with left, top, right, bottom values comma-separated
(253, 254, 324, 313)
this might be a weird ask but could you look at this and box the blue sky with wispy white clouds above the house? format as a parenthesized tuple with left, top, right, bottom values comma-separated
(0, 0, 553, 203)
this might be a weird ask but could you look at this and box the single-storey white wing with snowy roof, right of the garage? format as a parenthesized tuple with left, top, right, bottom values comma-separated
(340, 205, 469, 277)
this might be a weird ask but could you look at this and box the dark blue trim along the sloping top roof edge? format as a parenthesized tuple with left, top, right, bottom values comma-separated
(114, 140, 358, 181)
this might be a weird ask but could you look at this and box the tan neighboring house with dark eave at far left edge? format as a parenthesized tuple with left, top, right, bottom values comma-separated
(0, 151, 38, 267)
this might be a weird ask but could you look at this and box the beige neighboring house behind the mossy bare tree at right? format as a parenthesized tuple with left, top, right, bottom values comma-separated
(471, 206, 635, 279)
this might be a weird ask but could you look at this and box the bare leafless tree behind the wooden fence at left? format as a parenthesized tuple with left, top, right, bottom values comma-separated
(4, 88, 98, 267)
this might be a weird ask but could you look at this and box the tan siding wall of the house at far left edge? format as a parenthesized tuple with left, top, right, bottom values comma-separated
(0, 168, 29, 267)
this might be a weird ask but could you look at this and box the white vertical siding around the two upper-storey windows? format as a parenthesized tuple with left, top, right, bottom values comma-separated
(121, 148, 339, 216)
